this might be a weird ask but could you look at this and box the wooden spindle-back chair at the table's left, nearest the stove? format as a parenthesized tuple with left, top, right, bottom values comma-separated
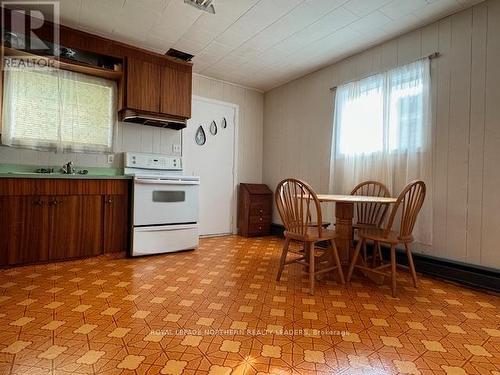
(274, 178, 344, 295)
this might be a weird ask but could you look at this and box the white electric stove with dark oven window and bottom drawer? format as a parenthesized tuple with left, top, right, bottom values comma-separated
(124, 152, 200, 256)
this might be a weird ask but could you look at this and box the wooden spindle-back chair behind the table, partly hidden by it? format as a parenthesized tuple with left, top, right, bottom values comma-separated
(351, 181, 391, 266)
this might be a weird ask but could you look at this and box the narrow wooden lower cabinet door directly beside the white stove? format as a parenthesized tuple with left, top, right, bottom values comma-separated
(103, 195, 130, 254)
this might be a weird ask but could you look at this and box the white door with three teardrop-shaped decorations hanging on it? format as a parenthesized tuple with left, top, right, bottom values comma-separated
(182, 98, 236, 235)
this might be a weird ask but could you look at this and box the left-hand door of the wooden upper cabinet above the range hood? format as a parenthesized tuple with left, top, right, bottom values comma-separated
(125, 57, 160, 113)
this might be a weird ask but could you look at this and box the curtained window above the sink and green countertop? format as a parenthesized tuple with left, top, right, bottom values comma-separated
(1, 62, 117, 152)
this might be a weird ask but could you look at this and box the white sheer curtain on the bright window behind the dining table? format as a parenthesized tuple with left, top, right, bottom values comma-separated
(330, 59, 432, 245)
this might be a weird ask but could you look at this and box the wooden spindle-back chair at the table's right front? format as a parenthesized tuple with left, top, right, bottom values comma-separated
(347, 181, 426, 297)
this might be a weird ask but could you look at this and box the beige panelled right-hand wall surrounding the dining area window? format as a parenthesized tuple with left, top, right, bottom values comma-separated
(263, 0, 500, 268)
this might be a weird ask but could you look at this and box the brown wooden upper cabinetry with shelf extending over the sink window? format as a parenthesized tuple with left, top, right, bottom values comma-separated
(0, 9, 192, 119)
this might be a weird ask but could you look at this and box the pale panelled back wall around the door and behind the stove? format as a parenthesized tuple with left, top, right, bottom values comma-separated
(0, 75, 264, 187)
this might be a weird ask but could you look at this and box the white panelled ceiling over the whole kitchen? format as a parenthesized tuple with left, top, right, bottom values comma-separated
(61, 0, 481, 91)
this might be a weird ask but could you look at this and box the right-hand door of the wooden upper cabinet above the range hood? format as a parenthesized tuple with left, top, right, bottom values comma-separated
(160, 66, 192, 118)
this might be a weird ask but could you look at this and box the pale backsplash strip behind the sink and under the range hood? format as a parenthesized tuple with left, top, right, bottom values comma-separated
(0, 123, 182, 168)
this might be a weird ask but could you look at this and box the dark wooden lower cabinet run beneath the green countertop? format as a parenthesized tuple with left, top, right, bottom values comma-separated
(0, 179, 129, 266)
